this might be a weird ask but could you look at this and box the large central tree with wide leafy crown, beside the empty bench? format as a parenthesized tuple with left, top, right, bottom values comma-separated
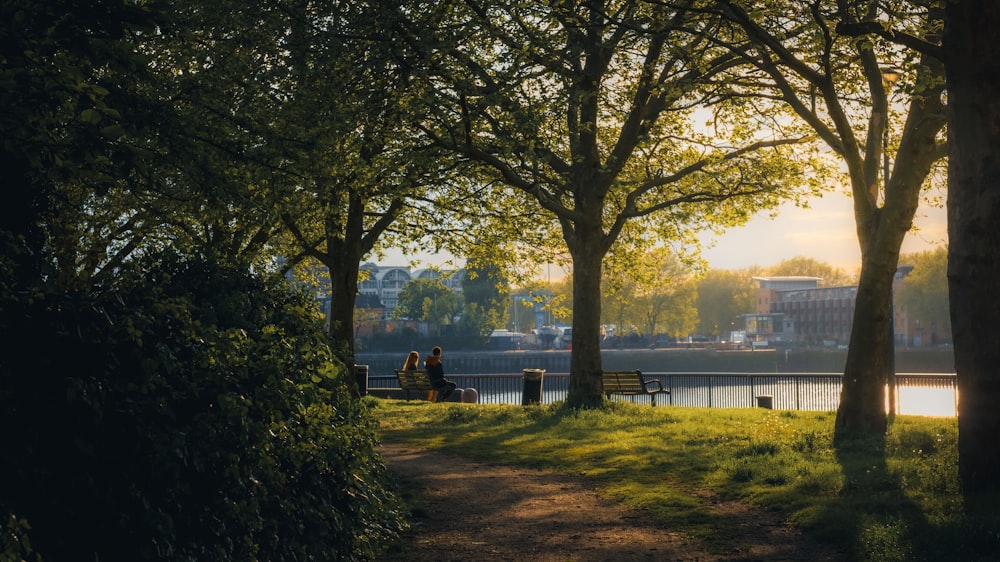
(406, 0, 816, 407)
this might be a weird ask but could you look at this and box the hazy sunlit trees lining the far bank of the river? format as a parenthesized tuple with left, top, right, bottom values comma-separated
(374, 252, 950, 349)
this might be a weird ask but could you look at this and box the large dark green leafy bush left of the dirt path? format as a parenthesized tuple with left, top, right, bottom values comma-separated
(0, 257, 405, 561)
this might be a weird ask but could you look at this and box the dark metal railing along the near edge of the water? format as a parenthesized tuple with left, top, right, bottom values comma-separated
(368, 372, 958, 416)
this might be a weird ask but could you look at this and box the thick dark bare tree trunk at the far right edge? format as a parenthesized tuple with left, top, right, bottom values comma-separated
(944, 0, 1000, 492)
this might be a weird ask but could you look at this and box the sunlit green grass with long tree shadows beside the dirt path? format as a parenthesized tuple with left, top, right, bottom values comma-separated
(367, 398, 1000, 561)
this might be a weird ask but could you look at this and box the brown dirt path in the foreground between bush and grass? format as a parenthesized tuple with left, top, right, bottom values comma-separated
(381, 444, 848, 562)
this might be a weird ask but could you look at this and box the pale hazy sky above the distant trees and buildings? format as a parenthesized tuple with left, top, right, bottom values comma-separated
(381, 192, 947, 274)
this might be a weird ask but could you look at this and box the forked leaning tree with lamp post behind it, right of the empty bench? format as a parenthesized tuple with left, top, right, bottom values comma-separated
(717, 0, 945, 435)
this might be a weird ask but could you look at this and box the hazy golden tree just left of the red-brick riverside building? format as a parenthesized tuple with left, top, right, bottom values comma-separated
(697, 269, 757, 337)
